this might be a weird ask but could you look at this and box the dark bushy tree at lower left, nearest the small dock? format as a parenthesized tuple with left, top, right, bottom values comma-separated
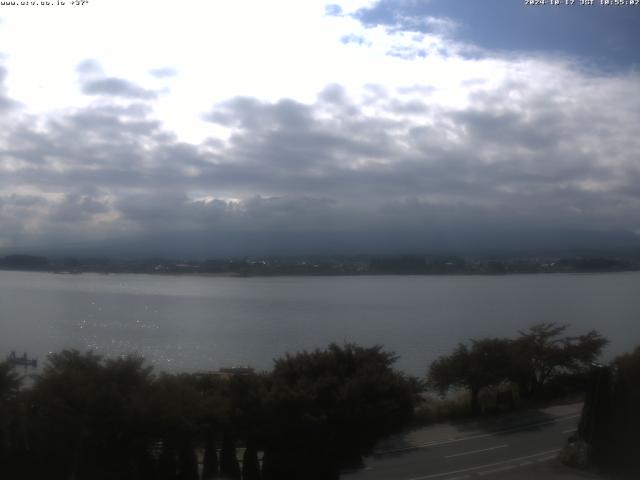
(28, 351, 159, 479)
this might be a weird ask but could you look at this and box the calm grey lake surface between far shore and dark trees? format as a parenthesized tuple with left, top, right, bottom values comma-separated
(0, 271, 640, 375)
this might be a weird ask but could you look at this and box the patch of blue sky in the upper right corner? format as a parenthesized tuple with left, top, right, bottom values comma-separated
(354, 0, 640, 68)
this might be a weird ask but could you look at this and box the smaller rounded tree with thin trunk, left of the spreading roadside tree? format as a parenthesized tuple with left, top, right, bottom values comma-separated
(427, 338, 511, 413)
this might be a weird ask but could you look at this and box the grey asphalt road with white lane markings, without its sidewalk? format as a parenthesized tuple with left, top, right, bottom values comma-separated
(341, 408, 579, 480)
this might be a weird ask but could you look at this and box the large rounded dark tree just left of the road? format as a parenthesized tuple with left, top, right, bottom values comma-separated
(263, 344, 418, 480)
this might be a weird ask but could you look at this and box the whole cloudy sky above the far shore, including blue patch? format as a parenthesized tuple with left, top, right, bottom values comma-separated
(0, 0, 640, 257)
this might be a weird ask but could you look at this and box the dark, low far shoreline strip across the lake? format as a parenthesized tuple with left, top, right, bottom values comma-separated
(0, 252, 640, 278)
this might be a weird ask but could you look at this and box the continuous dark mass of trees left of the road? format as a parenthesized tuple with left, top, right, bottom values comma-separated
(0, 344, 418, 480)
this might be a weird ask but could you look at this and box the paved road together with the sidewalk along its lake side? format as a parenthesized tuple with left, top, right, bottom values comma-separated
(342, 404, 604, 480)
